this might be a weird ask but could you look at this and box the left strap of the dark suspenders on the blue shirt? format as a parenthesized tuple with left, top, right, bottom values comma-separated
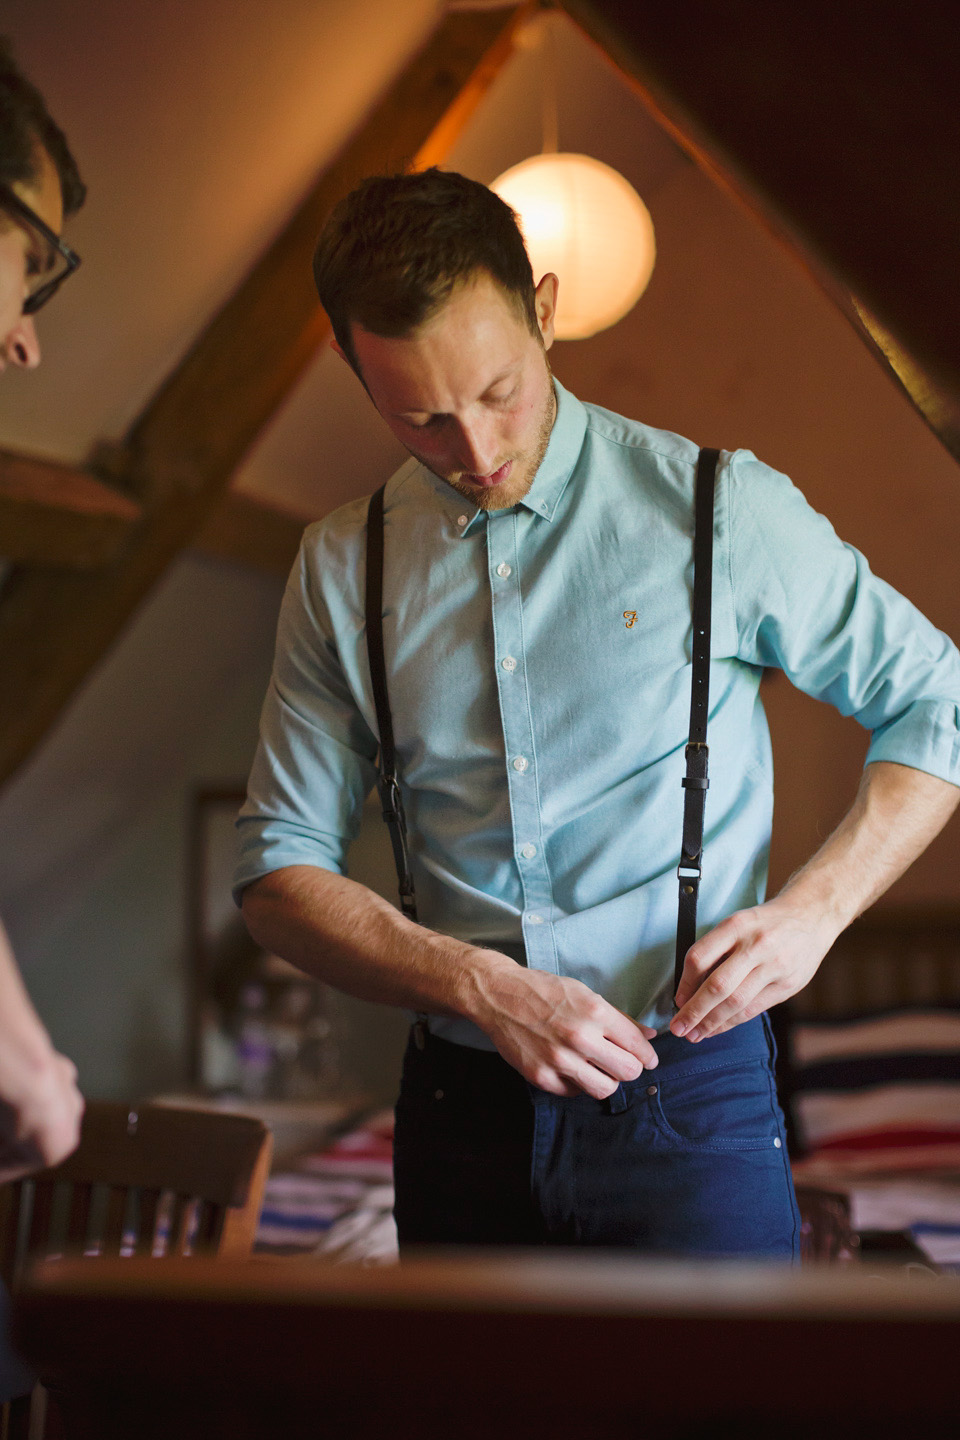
(367, 485, 417, 920)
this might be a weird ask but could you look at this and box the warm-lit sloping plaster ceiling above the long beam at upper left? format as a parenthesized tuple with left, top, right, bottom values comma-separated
(0, 0, 436, 462)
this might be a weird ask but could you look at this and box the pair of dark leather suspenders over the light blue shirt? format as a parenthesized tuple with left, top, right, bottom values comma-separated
(366, 449, 720, 989)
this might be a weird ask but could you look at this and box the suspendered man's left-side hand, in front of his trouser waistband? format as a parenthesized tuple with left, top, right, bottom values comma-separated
(472, 950, 658, 1100)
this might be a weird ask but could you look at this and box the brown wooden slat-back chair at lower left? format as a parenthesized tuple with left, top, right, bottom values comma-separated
(0, 1100, 272, 1440)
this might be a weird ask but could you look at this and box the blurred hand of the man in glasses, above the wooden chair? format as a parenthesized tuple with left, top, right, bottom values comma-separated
(0, 1048, 83, 1184)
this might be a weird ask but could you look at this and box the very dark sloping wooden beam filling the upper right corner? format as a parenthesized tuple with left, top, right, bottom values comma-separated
(560, 0, 960, 459)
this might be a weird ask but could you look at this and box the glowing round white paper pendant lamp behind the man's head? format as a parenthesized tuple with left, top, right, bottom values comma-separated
(491, 154, 656, 340)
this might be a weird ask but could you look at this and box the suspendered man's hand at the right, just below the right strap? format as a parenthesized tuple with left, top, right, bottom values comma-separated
(671, 891, 838, 1041)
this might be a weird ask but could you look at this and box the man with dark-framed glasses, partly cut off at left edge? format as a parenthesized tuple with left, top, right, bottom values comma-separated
(0, 42, 85, 1182)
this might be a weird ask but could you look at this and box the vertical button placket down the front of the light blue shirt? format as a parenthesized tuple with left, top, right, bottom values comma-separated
(486, 513, 557, 971)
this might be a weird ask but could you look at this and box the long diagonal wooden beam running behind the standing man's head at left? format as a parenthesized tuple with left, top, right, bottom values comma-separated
(0, 4, 531, 783)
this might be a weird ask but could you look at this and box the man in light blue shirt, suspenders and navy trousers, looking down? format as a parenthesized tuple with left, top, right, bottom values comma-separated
(237, 171, 960, 1259)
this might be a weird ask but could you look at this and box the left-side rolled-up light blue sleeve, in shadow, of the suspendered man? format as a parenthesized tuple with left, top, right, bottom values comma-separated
(233, 531, 377, 903)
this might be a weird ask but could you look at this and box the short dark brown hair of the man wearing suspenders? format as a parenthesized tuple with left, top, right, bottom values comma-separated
(314, 168, 540, 369)
